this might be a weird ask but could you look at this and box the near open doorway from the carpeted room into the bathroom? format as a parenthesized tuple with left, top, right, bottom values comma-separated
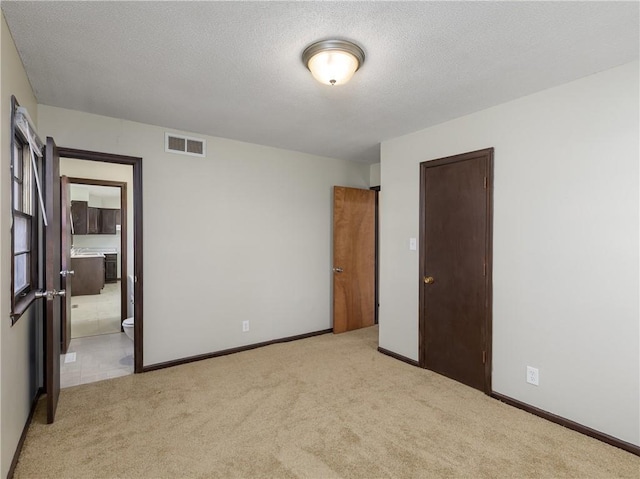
(60, 148, 141, 388)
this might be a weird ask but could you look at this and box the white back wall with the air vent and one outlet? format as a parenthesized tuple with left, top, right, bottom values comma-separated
(38, 105, 369, 365)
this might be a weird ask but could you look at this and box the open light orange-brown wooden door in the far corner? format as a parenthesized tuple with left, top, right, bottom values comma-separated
(333, 186, 376, 333)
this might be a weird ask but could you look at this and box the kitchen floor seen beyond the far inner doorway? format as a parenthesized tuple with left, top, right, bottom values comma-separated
(71, 281, 122, 338)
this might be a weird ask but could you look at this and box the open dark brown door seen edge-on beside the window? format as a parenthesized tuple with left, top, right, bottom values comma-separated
(44, 138, 64, 423)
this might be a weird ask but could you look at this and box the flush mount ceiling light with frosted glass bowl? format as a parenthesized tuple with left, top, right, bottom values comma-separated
(302, 40, 364, 85)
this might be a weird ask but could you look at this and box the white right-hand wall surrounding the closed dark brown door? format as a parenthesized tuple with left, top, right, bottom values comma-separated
(380, 62, 640, 445)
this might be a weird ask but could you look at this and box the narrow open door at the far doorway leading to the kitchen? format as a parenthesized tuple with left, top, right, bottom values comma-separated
(60, 176, 74, 354)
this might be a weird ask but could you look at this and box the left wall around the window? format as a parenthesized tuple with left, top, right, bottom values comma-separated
(0, 15, 38, 477)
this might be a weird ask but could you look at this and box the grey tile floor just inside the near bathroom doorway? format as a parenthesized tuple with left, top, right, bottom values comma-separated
(60, 333, 133, 388)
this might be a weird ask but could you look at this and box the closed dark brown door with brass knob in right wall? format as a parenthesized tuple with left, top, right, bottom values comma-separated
(420, 149, 493, 393)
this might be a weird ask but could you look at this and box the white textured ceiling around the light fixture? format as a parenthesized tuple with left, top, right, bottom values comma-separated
(2, 0, 640, 163)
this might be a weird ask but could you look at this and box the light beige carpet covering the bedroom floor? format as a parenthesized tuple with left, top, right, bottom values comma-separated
(15, 327, 640, 479)
